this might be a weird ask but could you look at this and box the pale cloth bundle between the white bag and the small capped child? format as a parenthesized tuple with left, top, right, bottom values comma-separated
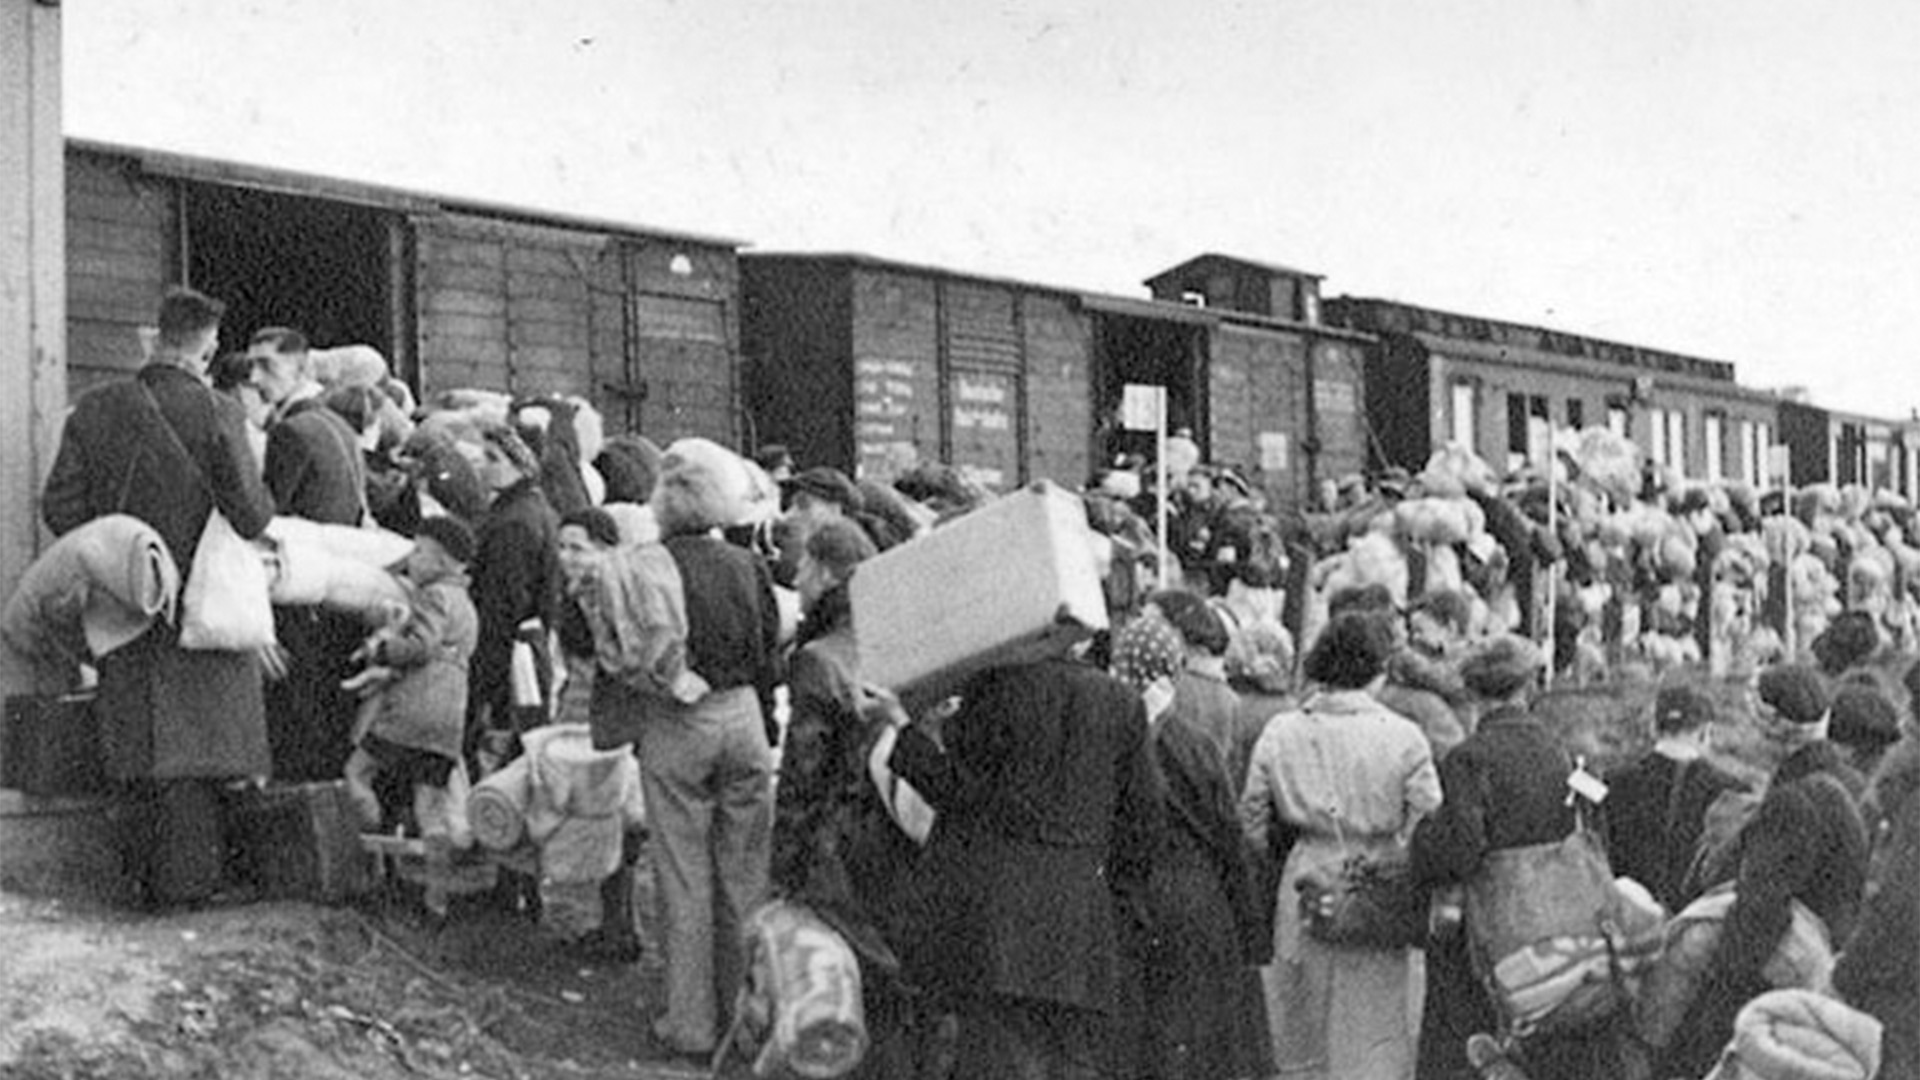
(267, 517, 413, 619)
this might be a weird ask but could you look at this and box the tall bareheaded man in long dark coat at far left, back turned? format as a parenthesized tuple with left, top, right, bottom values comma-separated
(40, 288, 273, 905)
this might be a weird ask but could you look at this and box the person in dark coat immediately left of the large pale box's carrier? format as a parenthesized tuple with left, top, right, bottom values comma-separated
(772, 521, 920, 1080)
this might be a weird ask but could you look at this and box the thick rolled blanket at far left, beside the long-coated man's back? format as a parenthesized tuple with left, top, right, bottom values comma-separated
(0, 513, 180, 661)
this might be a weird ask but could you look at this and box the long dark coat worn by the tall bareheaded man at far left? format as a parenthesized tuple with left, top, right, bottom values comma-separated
(40, 363, 273, 780)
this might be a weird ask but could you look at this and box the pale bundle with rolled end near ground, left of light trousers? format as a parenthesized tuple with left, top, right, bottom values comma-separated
(467, 724, 647, 884)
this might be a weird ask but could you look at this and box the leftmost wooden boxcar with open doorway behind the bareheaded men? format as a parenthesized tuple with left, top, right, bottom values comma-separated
(67, 142, 739, 444)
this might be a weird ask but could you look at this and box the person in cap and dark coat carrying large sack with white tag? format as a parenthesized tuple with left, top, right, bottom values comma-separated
(1413, 636, 1622, 1080)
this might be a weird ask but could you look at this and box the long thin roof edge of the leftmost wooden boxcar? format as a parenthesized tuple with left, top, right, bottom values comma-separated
(67, 138, 745, 248)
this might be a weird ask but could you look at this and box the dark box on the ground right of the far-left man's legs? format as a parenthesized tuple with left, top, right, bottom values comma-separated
(234, 780, 378, 903)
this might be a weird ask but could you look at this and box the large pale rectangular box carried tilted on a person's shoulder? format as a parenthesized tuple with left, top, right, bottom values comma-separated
(851, 480, 1106, 707)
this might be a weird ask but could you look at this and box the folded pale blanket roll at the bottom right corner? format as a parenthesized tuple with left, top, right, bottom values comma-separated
(1716, 990, 1882, 1080)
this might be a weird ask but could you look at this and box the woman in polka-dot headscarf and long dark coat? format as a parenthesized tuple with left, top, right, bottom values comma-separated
(1114, 594, 1273, 1080)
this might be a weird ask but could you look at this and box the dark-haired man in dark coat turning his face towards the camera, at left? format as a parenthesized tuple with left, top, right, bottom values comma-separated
(248, 327, 367, 782)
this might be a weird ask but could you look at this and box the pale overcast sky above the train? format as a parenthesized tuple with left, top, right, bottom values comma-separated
(61, 0, 1920, 417)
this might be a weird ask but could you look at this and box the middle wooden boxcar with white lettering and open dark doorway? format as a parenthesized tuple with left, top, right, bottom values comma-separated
(741, 252, 1367, 503)
